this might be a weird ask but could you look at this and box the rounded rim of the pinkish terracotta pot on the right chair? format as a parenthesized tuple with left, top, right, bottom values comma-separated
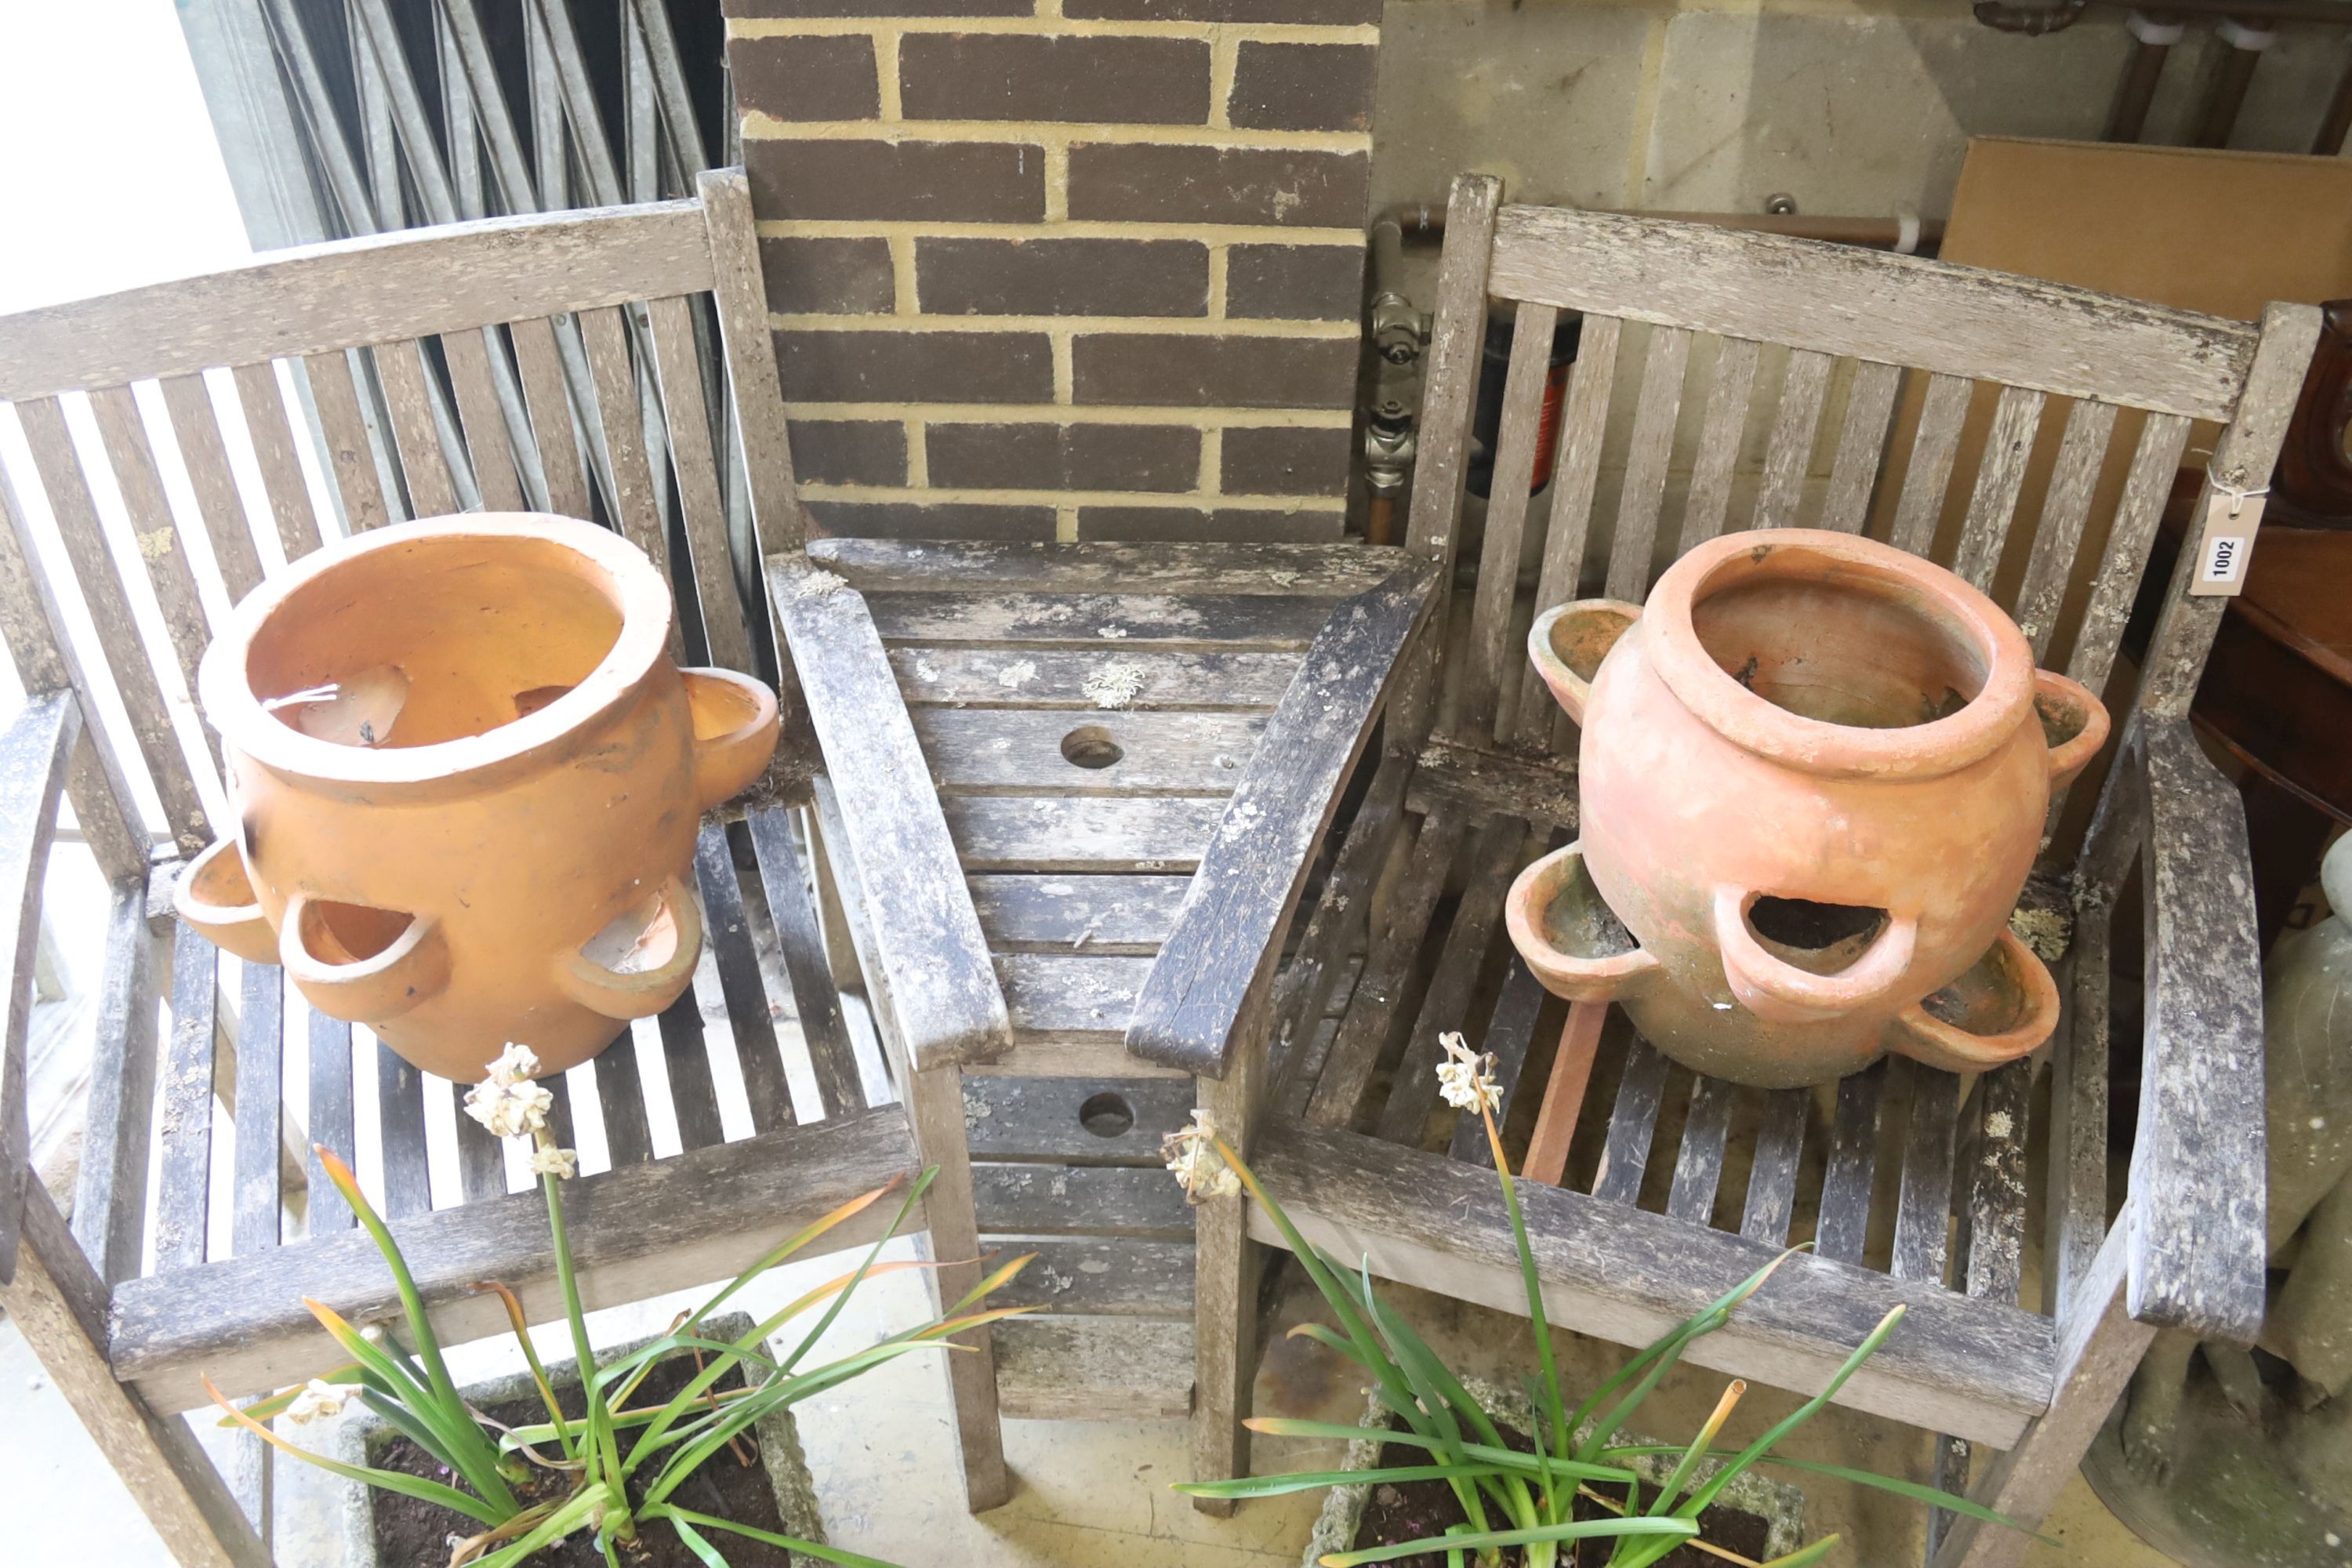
(1635, 529, 2034, 779)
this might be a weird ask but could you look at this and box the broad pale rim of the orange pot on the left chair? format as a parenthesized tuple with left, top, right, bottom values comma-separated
(198, 513, 673, 785)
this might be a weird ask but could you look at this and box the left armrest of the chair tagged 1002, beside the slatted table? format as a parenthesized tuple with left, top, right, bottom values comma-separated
(1127, 560, 1437, 1079)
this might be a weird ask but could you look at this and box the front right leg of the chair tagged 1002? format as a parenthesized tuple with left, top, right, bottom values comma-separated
(1933, 1210, 2157, 1568)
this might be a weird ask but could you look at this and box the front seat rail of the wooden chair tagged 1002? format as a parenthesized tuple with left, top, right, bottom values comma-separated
(1251, 1121, 2053, 1443)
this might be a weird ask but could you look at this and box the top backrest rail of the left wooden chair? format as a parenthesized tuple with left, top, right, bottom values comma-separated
(0, 202, 710, 400)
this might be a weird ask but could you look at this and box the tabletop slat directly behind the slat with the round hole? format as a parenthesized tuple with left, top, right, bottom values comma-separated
(889, 644, 1305, 713)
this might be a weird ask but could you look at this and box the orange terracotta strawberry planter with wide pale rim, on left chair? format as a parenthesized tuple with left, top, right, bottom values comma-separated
(174, 515, 776, 1081)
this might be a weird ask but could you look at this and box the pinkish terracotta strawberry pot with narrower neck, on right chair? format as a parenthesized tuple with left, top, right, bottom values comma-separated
(1508, 529, 2107, 1086)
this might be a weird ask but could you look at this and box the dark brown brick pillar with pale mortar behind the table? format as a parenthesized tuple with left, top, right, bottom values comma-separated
(727, 0, 1381, 541)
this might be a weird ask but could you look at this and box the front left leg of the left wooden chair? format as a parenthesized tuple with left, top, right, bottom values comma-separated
(0, 1180, 270, 1568)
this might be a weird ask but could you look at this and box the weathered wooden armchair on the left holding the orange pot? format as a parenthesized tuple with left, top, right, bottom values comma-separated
(0, 172, 1030, 1568)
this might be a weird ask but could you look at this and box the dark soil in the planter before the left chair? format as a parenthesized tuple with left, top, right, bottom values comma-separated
(369, 1356, 793, 1568)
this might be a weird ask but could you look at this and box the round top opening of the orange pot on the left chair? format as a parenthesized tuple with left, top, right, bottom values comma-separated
(245, 536, 623, 748)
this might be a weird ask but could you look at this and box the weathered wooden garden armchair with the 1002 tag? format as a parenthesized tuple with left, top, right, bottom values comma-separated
(1157, 179, 2317, 1568)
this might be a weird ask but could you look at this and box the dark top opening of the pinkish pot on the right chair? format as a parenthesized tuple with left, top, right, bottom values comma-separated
(1691, 546, 1992, 729)
